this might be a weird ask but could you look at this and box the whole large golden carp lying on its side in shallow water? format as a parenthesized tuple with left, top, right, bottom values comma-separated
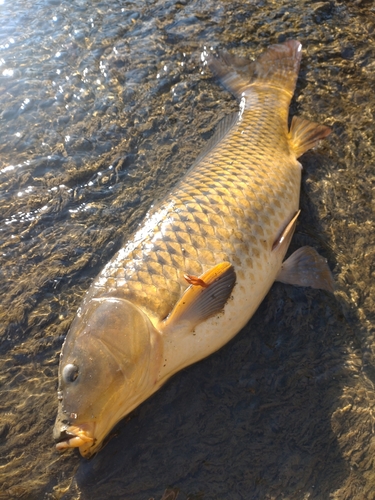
(53, 40, 334, 458)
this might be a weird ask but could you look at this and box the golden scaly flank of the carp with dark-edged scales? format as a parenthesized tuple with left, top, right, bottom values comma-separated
(87, 89, 300, 321)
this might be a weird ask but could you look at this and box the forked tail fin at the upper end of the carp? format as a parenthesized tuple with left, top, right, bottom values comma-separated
(206, 40, 302, 98)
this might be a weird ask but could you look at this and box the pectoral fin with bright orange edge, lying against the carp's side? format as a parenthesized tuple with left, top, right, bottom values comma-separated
(160, 262, 236, 333)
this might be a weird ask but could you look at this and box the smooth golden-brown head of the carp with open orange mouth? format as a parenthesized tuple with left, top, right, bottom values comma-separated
(54, 297, 161, 458)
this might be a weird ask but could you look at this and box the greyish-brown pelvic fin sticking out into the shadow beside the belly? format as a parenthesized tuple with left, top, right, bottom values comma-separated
(276, 247, 335, 292)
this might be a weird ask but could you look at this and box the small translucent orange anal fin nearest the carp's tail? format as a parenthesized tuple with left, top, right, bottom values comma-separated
(289, 116, 331, 158)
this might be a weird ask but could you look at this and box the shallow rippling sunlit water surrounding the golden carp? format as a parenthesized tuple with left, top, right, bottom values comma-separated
(0, 0, 375, 500)
